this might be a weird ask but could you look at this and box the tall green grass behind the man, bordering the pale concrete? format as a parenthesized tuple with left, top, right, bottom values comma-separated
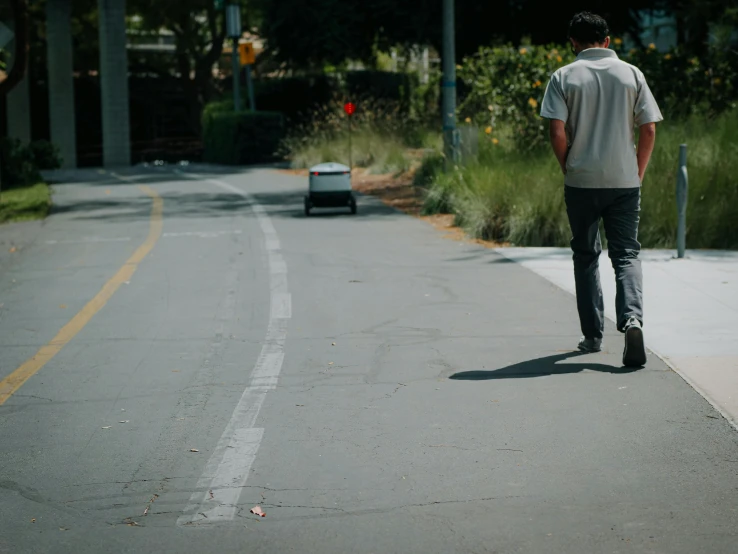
(425, 110, 738, 248)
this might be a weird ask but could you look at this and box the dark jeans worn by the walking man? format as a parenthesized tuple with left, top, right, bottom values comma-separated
(564, 187, 643, 338)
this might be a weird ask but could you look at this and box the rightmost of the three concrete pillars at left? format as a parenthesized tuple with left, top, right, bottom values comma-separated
(98, 0, 131, 167)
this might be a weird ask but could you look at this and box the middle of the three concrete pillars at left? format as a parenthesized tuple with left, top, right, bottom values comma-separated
(46, 0, 77, 168)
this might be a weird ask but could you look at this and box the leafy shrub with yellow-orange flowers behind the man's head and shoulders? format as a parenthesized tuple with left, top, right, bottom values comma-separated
(458, 38, 738, 150)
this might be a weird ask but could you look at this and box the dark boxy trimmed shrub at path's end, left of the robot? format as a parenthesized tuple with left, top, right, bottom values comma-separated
(203, 106, 284, 165)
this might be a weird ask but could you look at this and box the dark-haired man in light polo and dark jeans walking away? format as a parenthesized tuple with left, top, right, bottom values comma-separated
(541, 12, 663, 367)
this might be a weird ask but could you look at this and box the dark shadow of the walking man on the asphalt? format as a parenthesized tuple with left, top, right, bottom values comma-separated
(449, 352, 641, 381)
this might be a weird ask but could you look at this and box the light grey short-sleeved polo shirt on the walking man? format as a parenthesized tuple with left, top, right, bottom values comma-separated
(541, 48, 663, 188)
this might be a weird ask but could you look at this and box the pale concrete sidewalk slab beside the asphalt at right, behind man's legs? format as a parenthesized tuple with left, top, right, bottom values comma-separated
(497, 248, 738, 428)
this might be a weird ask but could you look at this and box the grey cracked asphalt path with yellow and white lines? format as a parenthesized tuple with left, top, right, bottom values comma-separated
(0, 168, 738, 554)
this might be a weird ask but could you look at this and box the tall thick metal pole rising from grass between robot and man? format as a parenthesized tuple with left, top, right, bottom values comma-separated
(442, 0, 458, 168)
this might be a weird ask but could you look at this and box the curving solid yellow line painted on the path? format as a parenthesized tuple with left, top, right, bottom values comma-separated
(0, 185, 164, 406)
